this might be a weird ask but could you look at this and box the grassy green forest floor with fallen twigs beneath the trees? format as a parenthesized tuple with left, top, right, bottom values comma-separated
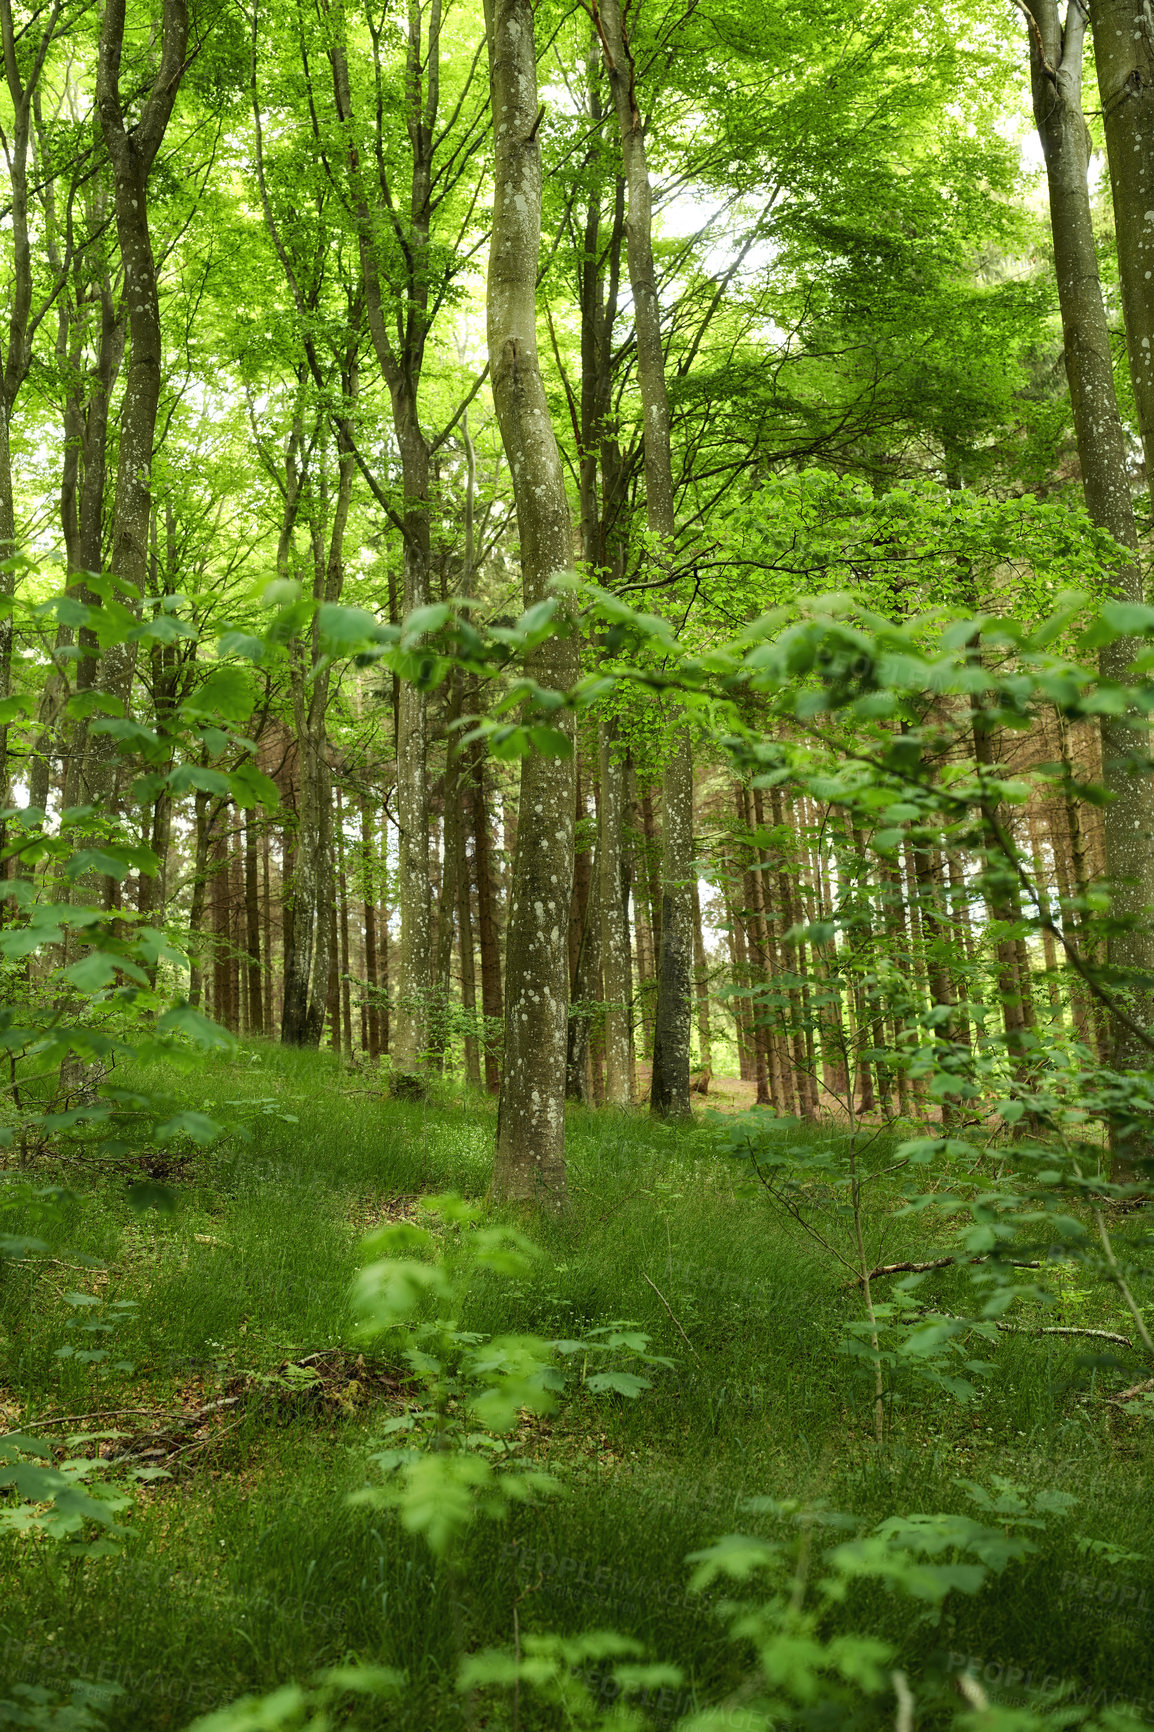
(0, 1044, 1154, 1732)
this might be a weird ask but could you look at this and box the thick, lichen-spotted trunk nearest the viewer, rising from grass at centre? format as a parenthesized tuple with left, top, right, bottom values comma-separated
(485, 0, 577, 1211)
